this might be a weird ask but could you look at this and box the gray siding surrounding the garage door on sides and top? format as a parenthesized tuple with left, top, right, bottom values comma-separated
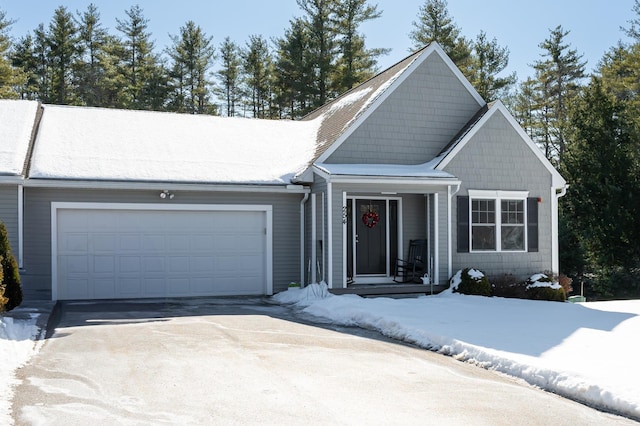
(22, 188, 302, 299)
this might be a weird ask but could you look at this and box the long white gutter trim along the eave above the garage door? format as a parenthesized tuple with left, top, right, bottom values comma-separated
(21, 179, 310, 193)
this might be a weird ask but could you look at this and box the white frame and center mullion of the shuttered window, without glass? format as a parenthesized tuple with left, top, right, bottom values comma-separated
(468, 189, 529, 253)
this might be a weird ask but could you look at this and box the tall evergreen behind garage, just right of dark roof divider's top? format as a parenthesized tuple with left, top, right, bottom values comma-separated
(47, 6, 80, 105)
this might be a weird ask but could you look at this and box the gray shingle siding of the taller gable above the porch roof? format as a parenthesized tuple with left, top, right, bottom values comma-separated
(327, 54, 480, 164)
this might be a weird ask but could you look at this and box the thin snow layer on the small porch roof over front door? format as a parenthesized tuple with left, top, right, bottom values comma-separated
(316, 161, 455, 179)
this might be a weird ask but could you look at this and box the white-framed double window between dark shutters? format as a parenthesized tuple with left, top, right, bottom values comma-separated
(469, 190, 528, 252)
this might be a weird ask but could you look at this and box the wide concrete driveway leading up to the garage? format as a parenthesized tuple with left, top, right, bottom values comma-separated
(13, 299, 635, 425)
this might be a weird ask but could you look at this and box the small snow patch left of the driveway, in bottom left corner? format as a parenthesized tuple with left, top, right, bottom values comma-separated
(0, 314, 40, 425)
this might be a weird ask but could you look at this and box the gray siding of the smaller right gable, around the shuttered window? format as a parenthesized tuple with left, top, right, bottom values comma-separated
(446, 109, 557, 278)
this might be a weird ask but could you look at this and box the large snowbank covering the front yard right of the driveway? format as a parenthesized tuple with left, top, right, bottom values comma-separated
(273, 283, 640, 419)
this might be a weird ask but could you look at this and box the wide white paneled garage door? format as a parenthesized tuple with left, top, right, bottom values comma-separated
(54, 209, 267, 300)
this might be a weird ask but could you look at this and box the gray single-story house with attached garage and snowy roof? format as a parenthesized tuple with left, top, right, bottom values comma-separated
(0, 43, 566, 300)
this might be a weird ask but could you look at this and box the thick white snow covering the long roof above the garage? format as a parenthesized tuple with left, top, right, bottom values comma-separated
(30, 105, 319, 184)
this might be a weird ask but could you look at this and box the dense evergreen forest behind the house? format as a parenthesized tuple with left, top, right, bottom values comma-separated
(0, 0, 640, 298)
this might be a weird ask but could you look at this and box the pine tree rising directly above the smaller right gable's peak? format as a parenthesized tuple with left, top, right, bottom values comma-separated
(465, 31, 516, 102)
